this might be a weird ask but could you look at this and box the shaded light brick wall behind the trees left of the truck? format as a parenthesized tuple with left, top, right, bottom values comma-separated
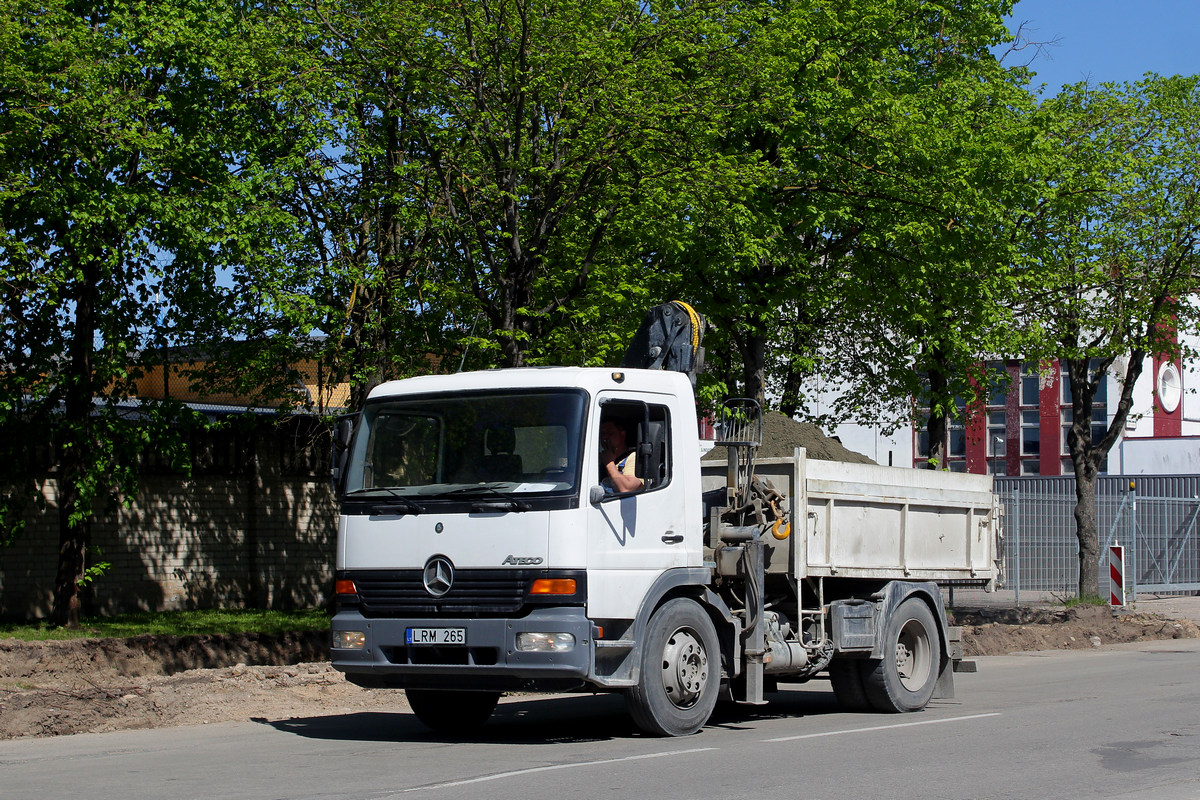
(0, 419, 337, 619)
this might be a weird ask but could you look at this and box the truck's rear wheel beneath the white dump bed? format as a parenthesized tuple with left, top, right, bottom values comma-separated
(862, 597, 942, 714)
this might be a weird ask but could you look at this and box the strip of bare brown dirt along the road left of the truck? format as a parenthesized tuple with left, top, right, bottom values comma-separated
(0, 631, 396, 739)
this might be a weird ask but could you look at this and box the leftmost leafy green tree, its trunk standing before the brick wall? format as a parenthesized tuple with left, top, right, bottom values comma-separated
(0, 0, 285, 624)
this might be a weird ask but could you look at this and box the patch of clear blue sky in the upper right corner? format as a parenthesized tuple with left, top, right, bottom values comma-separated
(1009, 0, 1200, 95)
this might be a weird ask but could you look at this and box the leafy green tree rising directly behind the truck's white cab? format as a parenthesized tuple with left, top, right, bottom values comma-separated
(395, 0, 734, 366)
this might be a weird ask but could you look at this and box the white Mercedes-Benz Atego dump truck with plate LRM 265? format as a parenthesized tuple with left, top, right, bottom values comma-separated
(331, 303, 1000, 735)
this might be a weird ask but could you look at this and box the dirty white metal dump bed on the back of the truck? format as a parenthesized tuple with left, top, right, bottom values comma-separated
(703, 449, 1001, 588)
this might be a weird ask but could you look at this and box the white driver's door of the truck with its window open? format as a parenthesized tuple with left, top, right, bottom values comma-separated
(587, 392, 688, 618)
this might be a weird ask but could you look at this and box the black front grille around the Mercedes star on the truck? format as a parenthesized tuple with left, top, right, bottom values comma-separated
(349, 570, 538, 618)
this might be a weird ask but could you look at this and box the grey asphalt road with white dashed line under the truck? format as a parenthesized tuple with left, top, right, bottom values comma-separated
(0, 640, 1200, 800)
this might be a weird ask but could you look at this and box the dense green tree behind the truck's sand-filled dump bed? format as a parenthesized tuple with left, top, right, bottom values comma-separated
(694, 0, 1030, 455)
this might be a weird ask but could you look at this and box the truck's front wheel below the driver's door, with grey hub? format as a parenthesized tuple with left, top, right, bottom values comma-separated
(625, 597, 721, 736)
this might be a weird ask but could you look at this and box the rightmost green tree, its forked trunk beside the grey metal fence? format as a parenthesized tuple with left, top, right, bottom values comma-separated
(1024, 76, 1200, 596)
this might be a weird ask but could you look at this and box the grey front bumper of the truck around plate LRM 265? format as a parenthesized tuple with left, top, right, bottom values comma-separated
(330, 608, 594, 691)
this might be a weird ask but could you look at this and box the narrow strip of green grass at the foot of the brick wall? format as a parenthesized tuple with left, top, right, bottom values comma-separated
(0, 609, 329, 642)
